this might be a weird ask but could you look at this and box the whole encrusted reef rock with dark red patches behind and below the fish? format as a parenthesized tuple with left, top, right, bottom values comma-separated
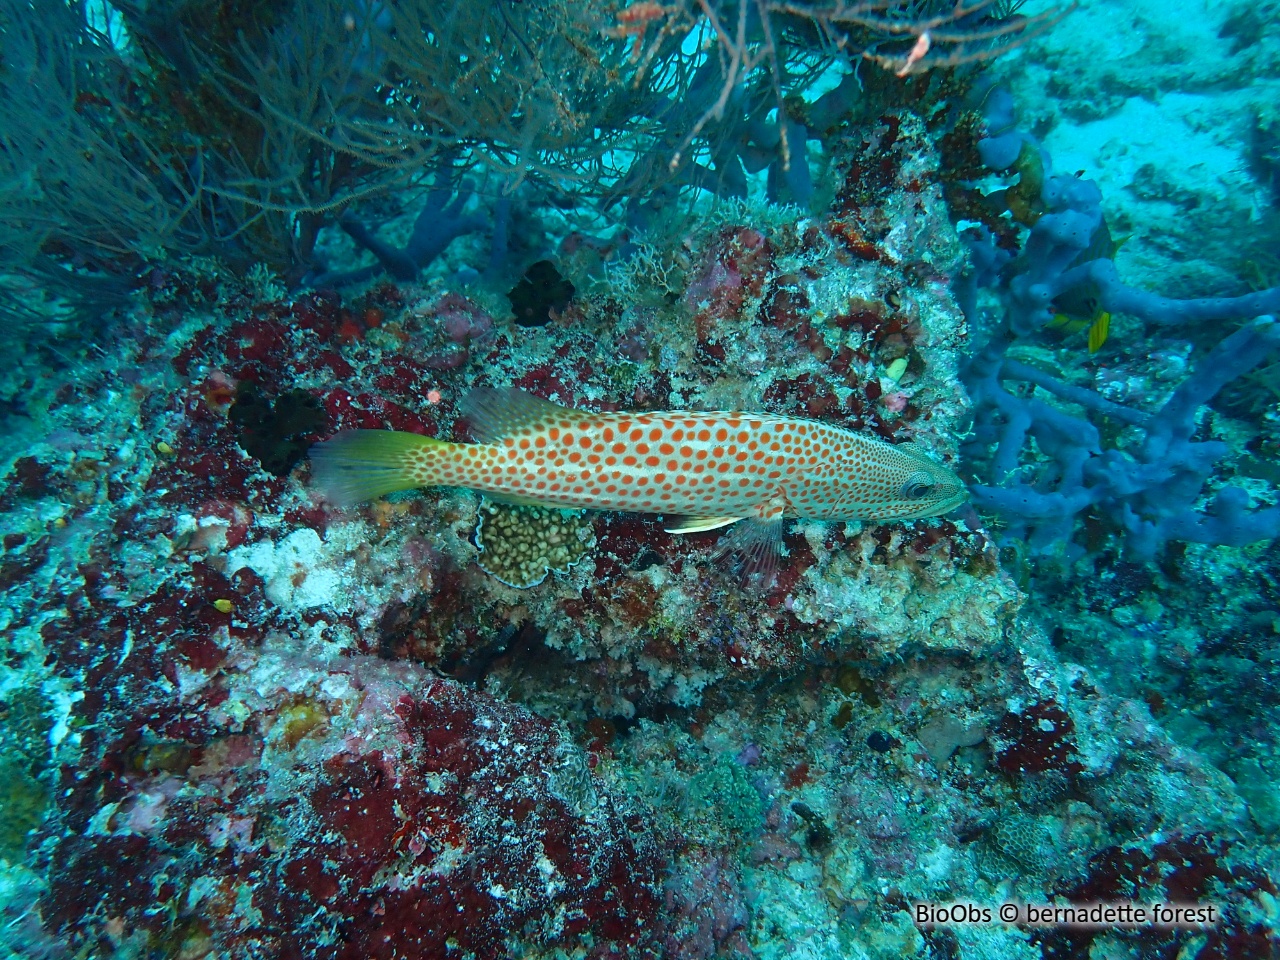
(0, 104, 1276, 960)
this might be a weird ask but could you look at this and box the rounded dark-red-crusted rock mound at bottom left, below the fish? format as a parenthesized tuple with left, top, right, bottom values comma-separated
(42, 650, 658, 957)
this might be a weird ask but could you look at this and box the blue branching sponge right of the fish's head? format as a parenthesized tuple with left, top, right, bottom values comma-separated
(955, 93, 1280, 559)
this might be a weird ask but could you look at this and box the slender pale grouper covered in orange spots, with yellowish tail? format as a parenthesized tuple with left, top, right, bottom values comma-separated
(311, 388, 968, 570)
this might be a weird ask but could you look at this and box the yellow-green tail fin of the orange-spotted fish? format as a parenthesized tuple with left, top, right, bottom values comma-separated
(307, 430, 457, 507)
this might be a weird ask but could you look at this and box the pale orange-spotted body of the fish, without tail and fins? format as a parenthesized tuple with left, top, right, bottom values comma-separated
(408, 412, 947, 520)
